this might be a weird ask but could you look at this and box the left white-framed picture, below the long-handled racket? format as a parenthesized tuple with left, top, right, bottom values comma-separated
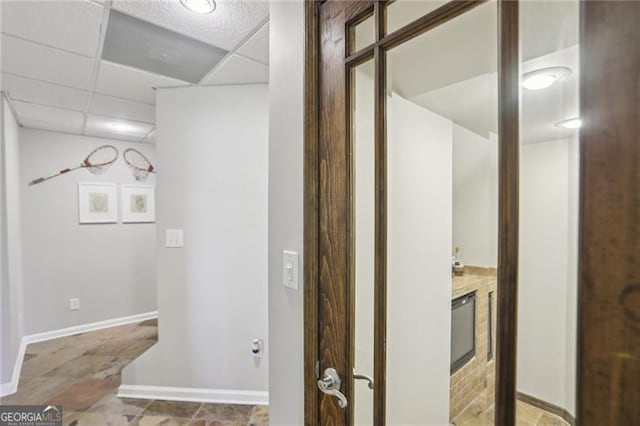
(78, 183, 118, 223)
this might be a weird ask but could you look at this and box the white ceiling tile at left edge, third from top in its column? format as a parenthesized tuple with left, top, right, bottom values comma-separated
(0, 73, 89, 111)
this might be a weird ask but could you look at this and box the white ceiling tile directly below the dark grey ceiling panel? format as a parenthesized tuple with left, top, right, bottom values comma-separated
(96, 61, 188, 104)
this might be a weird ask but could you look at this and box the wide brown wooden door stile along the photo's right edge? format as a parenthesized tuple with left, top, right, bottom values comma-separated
(576, 1, 640, 426)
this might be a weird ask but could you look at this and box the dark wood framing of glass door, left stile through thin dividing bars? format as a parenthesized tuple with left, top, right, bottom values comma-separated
(305, 0, 519, 425)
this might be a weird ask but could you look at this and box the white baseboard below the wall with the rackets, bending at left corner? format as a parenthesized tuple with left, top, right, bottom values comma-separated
(0, 311, 158, 397)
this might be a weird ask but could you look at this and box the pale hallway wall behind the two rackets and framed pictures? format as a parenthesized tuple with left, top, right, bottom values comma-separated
(19, 128, 157, 334)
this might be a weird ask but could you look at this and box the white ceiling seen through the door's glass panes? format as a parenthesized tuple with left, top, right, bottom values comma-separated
(387, 1, 579, 143)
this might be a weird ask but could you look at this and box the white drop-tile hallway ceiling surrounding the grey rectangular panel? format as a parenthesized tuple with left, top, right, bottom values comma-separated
(0, 0, 269, 141)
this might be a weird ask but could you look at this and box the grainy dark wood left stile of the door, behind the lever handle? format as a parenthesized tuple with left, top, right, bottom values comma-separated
(307, 1, 372, 425)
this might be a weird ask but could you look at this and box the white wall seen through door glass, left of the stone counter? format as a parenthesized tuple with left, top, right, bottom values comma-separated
(353, 72, 453, 425)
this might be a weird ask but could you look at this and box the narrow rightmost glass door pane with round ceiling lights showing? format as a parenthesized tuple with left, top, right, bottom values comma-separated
(517, 0, 580, 425)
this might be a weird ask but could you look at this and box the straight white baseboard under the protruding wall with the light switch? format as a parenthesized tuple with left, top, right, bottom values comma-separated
(118, 385, 269, 405)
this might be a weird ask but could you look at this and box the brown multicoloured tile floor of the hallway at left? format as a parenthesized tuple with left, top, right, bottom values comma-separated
(0, 320, 269, 426)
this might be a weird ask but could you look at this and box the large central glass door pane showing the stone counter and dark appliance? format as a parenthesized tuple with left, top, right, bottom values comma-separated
(386, 2, 498, 426)
